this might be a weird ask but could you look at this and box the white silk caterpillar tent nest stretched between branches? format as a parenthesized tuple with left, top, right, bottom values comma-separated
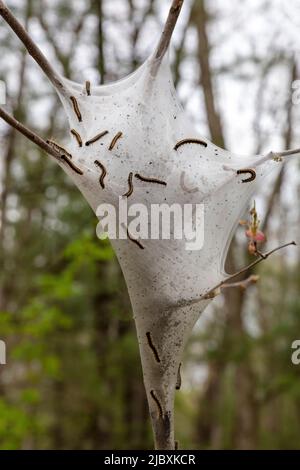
(0, 2, 292, 449)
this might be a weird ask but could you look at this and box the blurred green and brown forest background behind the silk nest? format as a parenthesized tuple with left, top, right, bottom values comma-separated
(0, 0, 300, 449)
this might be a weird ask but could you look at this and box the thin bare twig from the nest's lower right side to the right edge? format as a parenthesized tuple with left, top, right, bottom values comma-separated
(176, 241, 297, 308)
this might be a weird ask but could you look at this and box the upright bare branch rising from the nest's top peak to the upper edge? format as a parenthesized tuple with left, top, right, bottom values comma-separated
(152, 0, 184, 75)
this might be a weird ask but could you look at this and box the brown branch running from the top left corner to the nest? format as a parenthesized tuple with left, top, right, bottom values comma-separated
(0, 0, 65, 93)
